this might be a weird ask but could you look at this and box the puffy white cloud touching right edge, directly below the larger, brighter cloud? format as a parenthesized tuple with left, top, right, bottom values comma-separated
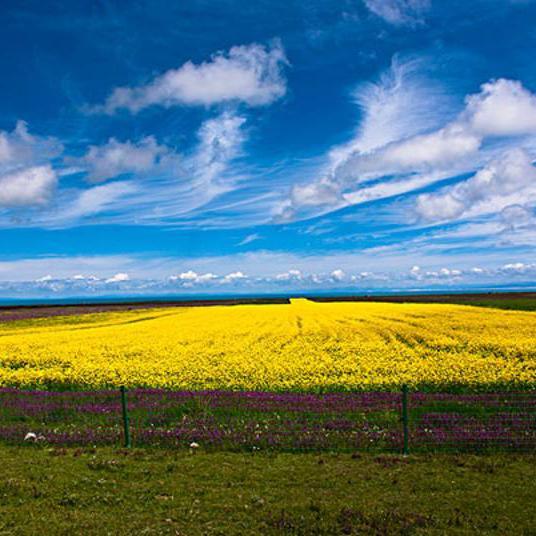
(416, 149, 536, 221)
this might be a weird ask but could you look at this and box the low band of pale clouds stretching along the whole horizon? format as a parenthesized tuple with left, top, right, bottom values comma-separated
(0, 251, 536, 297)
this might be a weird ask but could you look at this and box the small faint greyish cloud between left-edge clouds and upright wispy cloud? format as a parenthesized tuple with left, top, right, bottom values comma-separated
(77, 136, 177, 182)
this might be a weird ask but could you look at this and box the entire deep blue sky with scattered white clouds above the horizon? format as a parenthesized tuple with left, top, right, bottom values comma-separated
(0, 0, 536, 297)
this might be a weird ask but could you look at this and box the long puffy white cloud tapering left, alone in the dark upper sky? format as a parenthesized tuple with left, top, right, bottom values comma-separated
(97, 42, 287, 113)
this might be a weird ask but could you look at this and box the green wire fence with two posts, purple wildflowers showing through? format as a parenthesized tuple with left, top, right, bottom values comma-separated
(0, 388, 536, 453)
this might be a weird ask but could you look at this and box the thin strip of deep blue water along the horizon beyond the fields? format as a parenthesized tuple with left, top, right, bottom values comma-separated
(0, 283, 536, 306)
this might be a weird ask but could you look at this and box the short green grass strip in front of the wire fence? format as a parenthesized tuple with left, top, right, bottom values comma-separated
(0, 446, 536, 536)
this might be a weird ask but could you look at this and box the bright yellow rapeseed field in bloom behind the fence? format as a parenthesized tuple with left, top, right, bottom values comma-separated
(0, 299, 536, 390)
